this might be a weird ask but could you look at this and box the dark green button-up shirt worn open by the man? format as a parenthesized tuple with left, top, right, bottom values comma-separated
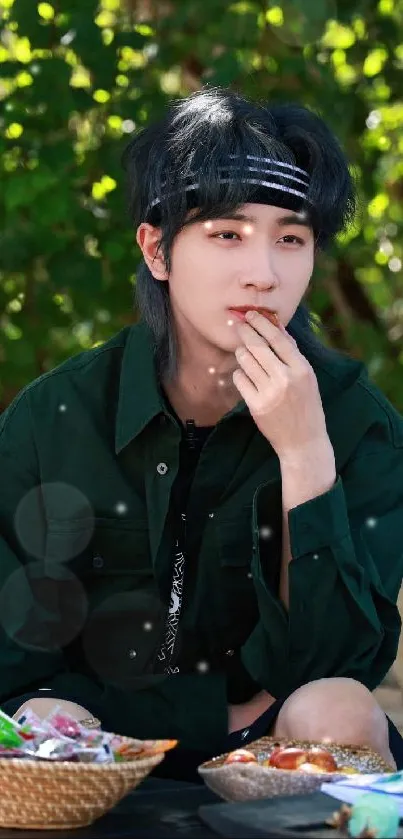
(0, 324, 403, 751)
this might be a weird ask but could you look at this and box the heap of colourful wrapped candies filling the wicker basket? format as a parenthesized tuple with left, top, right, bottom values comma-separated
(0, 706, 177, 763)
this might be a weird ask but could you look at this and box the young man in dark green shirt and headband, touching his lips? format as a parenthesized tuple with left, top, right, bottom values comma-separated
(0, 89, 403, 774)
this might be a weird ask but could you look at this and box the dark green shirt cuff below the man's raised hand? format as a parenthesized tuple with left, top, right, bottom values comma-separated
(288, 477, 350, 559)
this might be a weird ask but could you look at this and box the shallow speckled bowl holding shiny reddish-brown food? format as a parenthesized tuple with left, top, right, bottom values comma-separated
(198, 737, 393, 801)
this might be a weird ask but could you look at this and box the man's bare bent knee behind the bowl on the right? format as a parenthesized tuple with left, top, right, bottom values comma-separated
(274, 678, 393, 766)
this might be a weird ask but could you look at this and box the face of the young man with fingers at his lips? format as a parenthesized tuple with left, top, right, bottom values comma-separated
(140, 204, 314, 370)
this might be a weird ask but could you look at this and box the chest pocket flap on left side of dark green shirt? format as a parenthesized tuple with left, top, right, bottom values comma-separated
(45, 518, 153, 583)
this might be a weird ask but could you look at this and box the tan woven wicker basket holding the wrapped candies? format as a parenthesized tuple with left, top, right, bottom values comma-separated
(0, 752, 165, 830)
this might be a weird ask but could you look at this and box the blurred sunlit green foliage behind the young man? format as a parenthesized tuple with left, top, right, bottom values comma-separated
(0, 0, 403, 412)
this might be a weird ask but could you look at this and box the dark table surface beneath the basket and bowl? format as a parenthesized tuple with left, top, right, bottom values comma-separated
(0, 778, 403, 839)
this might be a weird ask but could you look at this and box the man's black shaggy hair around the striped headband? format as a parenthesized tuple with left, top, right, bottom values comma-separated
(122, 88, 356, 381)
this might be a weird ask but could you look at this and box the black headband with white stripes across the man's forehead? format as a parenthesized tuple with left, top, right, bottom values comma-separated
(146, 154, 312, 217)
